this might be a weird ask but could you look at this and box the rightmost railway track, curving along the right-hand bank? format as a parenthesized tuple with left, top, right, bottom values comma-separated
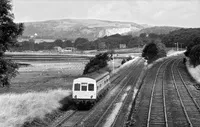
(171, 61, 200, 127)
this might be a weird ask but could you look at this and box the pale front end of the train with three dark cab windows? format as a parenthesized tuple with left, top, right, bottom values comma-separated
(72, 78, 97, 104)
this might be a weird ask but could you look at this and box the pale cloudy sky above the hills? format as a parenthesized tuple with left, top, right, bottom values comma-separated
(13, 0, 200, 27)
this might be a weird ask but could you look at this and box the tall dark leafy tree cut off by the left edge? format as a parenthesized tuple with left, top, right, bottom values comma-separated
(0, 0, 23, 86)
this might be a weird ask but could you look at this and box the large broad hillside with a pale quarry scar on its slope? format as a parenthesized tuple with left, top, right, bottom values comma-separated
(23, 19, 146, 40)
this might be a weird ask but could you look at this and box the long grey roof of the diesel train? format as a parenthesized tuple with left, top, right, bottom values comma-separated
(82, 70, 109, 80)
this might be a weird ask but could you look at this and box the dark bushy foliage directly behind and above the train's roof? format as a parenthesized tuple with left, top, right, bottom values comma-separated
(83, 53, 110, 74)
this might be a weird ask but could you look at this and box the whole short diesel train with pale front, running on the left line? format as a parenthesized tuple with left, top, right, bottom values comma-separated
(72, 71, 110, 104)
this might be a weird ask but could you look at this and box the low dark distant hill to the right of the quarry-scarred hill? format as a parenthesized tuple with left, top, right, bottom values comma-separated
(131, 26, 181, 36)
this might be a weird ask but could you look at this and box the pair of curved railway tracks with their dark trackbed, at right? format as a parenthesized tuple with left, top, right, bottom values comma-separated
(126, 56, 200, 127)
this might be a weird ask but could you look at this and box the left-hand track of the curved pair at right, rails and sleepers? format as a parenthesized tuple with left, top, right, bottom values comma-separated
(146, 60, 172, 127)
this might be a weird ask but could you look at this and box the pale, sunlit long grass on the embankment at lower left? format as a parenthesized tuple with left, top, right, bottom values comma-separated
(0, 89, 71, 127)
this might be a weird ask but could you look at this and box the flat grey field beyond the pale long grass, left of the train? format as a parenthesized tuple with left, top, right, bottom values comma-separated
(0, 59, 122, 93)
